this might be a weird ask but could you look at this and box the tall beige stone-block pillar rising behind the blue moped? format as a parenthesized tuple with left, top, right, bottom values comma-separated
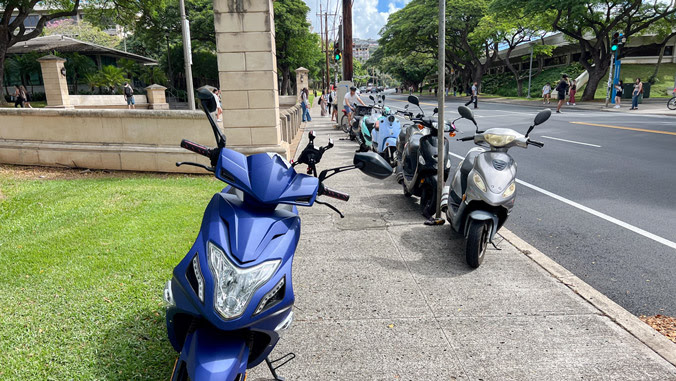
(214, 0, 289, 157)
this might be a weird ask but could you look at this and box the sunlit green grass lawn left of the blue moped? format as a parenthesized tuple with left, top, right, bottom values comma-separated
(0, 166, 224, 380)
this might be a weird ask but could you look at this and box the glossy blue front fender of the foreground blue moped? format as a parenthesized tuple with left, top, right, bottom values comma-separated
(171, 327, 249, 381)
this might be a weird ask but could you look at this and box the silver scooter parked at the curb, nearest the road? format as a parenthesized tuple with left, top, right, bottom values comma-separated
(441, 106, 552, 268)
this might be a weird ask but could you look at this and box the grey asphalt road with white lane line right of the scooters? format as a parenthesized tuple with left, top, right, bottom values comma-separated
(386, 94, 676, 316)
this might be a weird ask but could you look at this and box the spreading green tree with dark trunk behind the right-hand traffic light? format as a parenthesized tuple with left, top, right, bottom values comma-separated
(496, 0, 676, 100)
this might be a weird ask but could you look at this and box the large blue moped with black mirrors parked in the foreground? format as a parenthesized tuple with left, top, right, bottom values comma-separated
(164, 89, 392, 381)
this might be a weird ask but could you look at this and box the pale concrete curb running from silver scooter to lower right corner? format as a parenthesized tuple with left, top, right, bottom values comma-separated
(500, 227, 676, 366)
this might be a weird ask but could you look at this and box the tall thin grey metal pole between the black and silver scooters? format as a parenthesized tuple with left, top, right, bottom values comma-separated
(436, 0, 446, 220)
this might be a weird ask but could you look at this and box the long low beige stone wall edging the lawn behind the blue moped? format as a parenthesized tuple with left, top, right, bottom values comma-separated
(0, 108, 282, 173)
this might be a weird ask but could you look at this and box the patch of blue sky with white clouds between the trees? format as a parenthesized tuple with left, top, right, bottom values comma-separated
(304, 0, 410, 39)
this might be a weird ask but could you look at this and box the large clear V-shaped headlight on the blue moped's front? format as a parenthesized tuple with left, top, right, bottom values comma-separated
(208, 242, 281, 319)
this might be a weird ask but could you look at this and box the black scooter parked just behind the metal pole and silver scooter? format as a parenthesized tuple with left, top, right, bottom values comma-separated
(396, 95, 455, 218)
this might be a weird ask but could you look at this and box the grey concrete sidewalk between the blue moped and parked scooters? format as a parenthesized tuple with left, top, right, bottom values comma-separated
(248, 108, 676, 380)
